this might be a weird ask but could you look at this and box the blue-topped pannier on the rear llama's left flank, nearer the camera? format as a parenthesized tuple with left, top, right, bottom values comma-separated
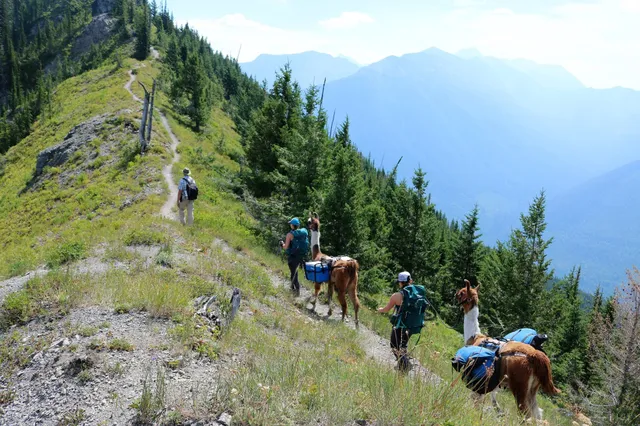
(451, 346, 500, 394)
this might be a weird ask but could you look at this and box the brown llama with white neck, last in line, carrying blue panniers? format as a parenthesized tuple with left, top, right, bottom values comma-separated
(456, 280, 560, 420)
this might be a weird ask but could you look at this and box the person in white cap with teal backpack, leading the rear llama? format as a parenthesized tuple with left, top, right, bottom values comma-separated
(378, 271, 427, 372)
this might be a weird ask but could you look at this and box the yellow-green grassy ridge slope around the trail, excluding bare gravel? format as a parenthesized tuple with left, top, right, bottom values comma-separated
(0, 55, 570, 425)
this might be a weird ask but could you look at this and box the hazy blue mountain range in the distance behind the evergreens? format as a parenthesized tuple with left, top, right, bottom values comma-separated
(242, 48, 640, 290)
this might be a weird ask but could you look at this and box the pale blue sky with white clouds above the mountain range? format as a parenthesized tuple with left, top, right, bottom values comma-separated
(168, 0, 640, 90)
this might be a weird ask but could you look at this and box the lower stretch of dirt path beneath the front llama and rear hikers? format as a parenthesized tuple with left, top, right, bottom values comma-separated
(214, 238, 442, 383)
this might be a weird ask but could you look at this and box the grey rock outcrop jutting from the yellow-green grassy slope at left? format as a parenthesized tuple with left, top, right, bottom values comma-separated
(34, 115, 107, 178)
